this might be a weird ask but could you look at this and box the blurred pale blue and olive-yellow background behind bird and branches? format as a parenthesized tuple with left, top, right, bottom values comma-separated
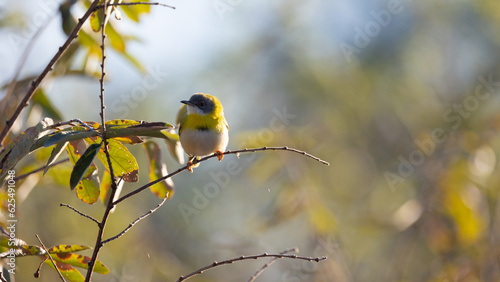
(0, 0, 500, 281)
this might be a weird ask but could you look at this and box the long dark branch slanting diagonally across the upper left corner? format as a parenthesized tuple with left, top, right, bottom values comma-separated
(0, 0, 100, 148)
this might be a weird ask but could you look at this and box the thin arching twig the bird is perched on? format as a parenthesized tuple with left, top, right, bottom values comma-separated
(113, 146, 330, 205)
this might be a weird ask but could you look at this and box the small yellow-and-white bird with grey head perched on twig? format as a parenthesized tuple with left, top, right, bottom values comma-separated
(177, 93, 229, 172)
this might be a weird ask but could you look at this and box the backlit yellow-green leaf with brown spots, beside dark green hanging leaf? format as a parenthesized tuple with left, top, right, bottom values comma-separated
(86, 137, 139, 182)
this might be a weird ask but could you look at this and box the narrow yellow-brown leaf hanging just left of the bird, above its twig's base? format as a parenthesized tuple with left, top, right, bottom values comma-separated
(144, 141, 174, 199)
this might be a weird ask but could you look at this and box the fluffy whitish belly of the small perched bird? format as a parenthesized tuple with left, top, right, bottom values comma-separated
(180, 129, 229, 156)
